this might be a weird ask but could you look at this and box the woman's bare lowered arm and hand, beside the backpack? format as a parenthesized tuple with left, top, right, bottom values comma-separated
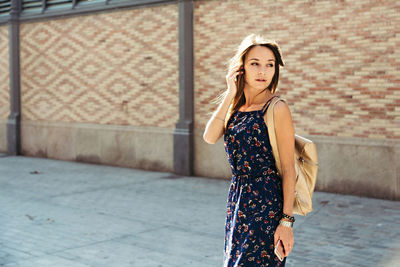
(273, 101, 296, 257)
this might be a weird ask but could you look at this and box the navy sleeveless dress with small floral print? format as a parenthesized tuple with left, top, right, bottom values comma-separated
(223, 98, 286, 267)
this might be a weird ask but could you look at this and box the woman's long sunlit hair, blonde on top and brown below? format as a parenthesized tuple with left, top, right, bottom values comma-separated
(212, 33, 285, 132)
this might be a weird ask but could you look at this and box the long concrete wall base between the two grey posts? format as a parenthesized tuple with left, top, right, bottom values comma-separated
(21, 121, 173, 171)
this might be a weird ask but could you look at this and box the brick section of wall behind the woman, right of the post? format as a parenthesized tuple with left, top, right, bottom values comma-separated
(194, 0, 400, 139)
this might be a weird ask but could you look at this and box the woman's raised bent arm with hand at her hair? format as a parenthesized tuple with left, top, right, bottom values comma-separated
(203, 66, 242, 144)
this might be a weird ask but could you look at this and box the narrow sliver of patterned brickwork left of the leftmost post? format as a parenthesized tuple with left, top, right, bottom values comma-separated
(0, 25, 10, 120)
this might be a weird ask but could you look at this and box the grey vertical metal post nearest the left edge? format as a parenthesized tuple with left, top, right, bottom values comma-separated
(7, 0, 21, 155)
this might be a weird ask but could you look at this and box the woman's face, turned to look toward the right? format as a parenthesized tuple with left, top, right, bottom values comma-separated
(244, 45, 276, 90)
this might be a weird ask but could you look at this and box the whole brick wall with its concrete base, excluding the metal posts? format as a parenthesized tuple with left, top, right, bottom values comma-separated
(0, 0, 400, 199)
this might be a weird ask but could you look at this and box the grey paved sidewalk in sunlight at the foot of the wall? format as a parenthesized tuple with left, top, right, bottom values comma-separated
(0, 156, 400, 267)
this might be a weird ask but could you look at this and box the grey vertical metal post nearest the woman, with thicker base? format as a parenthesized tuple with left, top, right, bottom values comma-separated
(174, 0, 194, 176)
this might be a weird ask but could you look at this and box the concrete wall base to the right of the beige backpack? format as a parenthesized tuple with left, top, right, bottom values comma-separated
(316, 138, 400, 199)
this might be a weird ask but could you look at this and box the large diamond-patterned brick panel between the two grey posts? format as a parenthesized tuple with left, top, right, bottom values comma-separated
(21, 4, 178, 128)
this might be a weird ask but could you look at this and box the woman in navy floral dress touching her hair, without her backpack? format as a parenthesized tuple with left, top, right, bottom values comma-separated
(203, 34, 295, 267)
